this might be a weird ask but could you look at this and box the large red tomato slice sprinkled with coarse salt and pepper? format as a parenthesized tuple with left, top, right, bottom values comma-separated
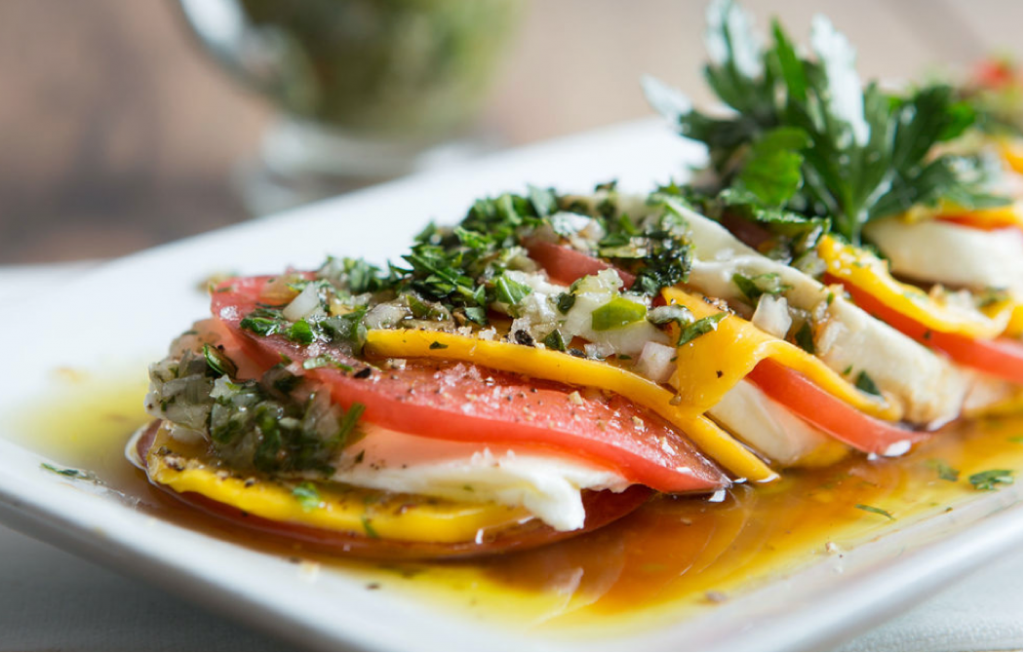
(213, 277, 729, 492)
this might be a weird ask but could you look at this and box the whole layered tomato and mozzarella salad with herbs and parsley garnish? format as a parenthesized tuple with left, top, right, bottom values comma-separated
(130, 1, 1024, 558)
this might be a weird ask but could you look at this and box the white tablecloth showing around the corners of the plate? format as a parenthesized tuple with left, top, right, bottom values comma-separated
(0, 264, 1024, 653)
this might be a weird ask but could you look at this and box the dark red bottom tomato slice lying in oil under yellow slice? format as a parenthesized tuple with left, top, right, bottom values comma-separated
(136, 421, 651, 560)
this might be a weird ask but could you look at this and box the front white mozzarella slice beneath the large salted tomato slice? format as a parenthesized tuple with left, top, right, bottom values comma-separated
(332, 427, 630, 530)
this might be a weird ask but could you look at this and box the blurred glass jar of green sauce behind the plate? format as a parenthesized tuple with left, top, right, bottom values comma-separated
(180, 0, 524, 213)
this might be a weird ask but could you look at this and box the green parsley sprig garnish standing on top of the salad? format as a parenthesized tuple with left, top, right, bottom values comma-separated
(644, 0, 1008, 244)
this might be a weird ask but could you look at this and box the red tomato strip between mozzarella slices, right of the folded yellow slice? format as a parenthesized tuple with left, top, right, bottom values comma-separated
(746, 358, 931, 454)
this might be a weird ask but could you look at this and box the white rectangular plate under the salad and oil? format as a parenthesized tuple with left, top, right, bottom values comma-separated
(0, 122, 1024, 651)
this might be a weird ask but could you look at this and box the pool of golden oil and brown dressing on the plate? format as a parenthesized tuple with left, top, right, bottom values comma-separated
(15, 377, 1024, 637)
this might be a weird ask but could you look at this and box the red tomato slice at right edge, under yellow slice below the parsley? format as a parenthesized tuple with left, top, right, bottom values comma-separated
(825, 276, 1024, 384)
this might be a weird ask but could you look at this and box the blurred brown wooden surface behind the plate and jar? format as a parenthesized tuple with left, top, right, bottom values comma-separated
(0, 0, 1024, 264)
